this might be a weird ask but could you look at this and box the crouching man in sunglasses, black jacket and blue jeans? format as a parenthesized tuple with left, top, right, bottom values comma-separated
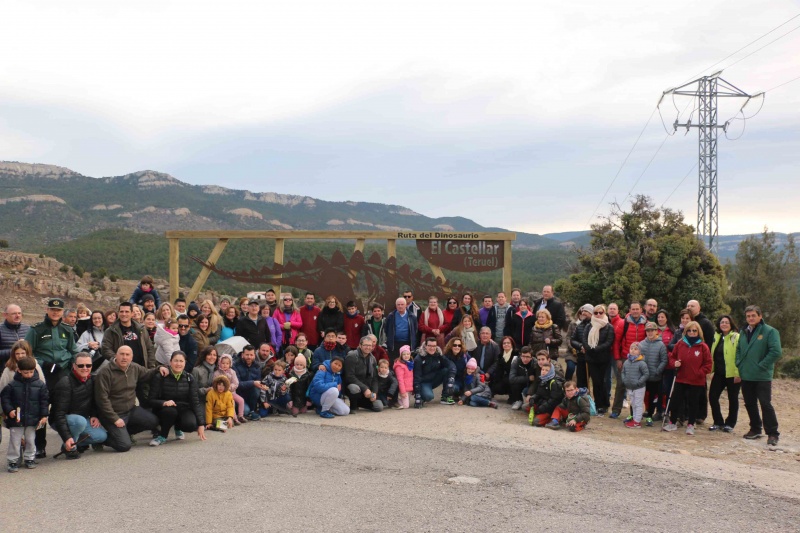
(50, 352, 107, 459)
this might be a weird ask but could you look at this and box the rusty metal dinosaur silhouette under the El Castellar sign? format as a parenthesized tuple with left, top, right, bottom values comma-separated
(192, 250, 475, 309)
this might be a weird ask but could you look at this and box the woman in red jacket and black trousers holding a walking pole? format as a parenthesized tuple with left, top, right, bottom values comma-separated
(664, 321, 712, 435)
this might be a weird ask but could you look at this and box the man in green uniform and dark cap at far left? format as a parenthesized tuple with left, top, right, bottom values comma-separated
(25, 298, 78, 459)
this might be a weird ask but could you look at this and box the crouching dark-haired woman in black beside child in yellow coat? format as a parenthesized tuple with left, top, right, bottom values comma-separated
(149, 350, 206, 446)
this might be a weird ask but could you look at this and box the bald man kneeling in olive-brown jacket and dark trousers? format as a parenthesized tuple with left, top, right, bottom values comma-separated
(94, 344, 169, 452)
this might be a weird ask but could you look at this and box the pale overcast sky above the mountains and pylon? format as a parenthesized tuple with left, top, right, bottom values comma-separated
(0, 0, 800, 234)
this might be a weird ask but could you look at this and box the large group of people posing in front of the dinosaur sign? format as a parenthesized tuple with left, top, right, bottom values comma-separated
(0, 276, 781, 472)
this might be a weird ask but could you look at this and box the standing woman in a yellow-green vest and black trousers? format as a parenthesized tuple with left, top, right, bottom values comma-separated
(708, 315, 742, 433)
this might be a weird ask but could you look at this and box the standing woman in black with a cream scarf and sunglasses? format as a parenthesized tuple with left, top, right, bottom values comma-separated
(583, 304, 614, 415)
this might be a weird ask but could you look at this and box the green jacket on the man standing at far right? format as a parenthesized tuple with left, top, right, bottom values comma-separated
(736, 320, 782, 381)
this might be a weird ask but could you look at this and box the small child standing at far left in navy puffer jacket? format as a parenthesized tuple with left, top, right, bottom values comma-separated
(0, 357, 50, 473)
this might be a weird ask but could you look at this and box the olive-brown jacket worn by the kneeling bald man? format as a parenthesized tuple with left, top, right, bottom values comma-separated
(94, 361, 158, 424)
